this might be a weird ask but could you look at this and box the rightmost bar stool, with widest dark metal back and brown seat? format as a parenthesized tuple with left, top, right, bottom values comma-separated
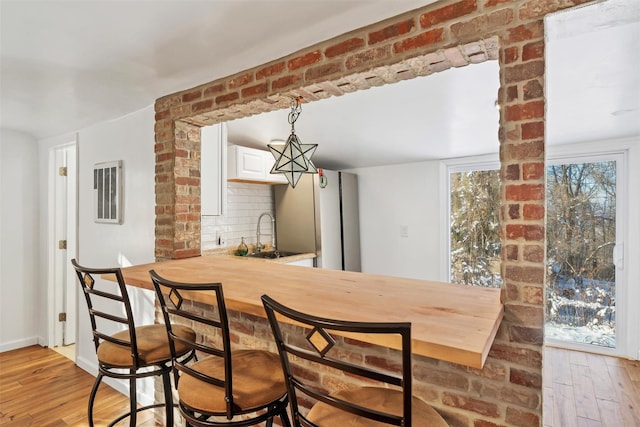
(262, 295, 447, 427)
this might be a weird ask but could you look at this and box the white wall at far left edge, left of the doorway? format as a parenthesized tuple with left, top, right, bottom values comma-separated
(0, 129, 41, 352)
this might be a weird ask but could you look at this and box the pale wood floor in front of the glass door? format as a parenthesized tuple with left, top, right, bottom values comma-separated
(542, 347, 640, 427)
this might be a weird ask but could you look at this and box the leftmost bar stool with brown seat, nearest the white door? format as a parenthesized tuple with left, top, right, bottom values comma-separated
(71, 259, 195, 426)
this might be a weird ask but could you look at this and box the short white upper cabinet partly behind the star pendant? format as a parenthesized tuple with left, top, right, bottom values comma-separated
(227, 144, 287, 184)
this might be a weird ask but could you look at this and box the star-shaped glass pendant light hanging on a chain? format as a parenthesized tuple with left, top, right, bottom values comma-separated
(267, 97, 318, 188)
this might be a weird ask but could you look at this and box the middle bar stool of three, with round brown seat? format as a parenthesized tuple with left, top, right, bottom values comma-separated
(150, 270, 291, 427)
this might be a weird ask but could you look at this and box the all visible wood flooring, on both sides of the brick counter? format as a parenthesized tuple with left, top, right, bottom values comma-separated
(0, 346, 640, 427)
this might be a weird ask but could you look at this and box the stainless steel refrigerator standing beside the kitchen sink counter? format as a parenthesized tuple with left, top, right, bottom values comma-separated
(274, 170, 361, 271)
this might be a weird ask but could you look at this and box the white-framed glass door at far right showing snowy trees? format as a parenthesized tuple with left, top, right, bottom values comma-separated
(545, 154, 629, 356)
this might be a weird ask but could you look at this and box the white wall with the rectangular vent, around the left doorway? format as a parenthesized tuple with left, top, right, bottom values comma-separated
(39, 106, 155, 402)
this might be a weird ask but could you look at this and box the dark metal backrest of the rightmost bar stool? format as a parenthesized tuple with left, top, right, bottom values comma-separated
(262, 295, 412, 427)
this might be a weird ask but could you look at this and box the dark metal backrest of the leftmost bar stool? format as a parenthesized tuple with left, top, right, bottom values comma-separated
(71, 259, 141, 369)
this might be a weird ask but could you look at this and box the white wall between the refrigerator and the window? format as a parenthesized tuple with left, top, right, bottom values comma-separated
(350, 161, 443, 280)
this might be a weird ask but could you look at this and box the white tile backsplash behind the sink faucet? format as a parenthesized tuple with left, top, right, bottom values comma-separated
(201, 182, 275, 251)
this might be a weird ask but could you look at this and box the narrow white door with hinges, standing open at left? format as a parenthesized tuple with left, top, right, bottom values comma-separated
(50, 144, 78, 346)
